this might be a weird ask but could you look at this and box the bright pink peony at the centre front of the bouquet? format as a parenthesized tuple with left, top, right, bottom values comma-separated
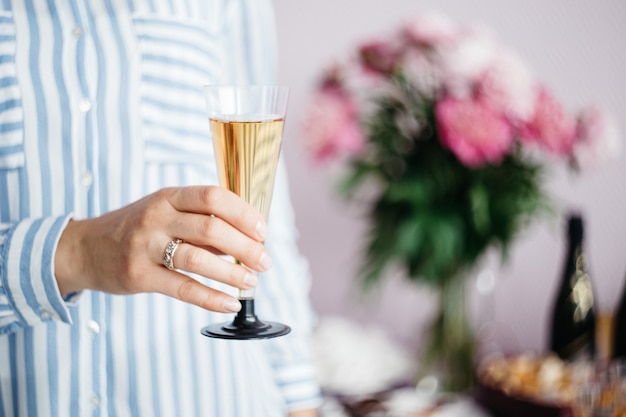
(435, 98, 513, 167)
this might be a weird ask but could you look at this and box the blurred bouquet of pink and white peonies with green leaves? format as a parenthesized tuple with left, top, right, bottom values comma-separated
(304, 14, 618, 390)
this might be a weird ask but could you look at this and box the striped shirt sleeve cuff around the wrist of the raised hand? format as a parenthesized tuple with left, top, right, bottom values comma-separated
(0, 216, 71, 334)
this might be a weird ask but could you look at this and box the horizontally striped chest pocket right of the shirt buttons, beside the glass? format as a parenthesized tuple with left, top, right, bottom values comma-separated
(133, 15, 221, 163)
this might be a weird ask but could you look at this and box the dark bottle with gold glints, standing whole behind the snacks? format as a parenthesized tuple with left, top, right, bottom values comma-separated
(550, 214, 596, 361)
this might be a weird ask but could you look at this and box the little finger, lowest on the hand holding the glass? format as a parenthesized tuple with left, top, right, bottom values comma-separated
(153, 268, 241, 313)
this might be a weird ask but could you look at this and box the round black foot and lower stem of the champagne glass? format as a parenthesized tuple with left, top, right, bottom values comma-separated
(200, 300, 291, 340)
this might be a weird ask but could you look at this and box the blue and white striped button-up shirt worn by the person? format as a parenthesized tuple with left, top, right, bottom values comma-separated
(0, 0, 319, 417)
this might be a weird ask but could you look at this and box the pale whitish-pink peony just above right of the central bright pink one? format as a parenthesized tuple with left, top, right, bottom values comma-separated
(477, 49, 535, 121)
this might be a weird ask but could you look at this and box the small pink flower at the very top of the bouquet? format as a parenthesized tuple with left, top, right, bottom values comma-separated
(402, 13, 459, 47)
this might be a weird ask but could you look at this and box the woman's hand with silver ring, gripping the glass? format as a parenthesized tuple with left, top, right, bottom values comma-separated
(55, 186, 271, 312)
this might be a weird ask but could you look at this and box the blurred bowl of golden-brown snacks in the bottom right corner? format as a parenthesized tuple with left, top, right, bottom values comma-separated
(474, 354, 626, 417)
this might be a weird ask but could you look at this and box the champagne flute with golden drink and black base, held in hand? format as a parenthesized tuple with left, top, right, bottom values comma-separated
(201, 86, 291, 339)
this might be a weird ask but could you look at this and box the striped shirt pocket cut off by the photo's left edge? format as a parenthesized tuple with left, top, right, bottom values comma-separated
(0, 11, 25, 170)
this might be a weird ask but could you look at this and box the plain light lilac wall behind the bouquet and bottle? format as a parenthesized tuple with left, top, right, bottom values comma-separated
(274, 0, 626, 350)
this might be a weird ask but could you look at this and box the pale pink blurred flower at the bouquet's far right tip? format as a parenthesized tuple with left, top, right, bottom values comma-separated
(572, 107, 622, 169)
